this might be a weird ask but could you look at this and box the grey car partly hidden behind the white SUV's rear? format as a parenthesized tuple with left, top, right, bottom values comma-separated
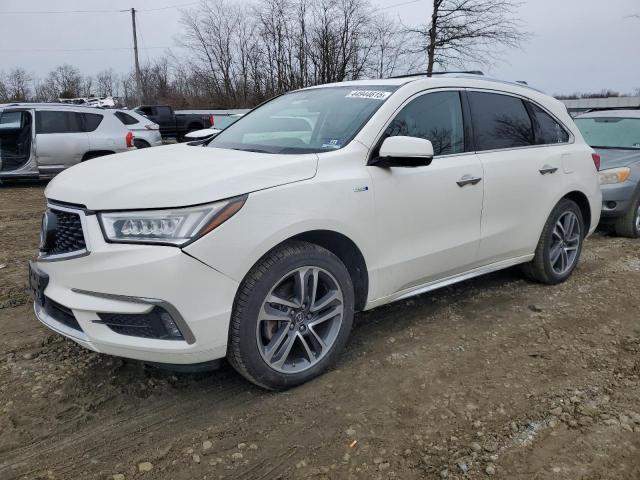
(575, 110, 640, 238)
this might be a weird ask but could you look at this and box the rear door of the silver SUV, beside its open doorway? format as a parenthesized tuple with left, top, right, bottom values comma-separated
(36, 110, 89, 172)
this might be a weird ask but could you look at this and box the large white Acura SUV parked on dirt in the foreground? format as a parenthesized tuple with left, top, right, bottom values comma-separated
(30, 75, 601, 389)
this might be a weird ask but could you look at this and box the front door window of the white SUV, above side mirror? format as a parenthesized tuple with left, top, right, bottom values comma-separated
(385, 92, 464, 155)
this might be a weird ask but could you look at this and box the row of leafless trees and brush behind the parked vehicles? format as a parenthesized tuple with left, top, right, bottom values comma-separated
(0, 0, 527, 108)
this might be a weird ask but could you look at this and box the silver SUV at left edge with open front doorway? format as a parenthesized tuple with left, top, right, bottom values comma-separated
(0, 103, 135, 179)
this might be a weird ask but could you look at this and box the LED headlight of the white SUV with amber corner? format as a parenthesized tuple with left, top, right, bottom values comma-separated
(98, 195, 247, 246)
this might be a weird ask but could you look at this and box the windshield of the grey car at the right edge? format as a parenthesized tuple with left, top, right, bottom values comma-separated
(575, 117, 640, 149)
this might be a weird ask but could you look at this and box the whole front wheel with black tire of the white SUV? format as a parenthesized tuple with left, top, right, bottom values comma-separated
(227, 241, 354, 390)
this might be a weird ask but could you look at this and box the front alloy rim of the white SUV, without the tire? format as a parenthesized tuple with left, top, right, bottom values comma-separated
(256, 266, 344, 373)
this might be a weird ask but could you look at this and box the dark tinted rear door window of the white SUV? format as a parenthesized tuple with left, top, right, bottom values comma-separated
(469, 92, 534, 150)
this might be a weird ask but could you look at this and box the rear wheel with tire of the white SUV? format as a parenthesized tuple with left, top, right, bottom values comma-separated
(522, 198, 586, 285)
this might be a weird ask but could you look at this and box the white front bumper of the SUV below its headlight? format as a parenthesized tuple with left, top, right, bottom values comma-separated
(35, 215, 238, 364)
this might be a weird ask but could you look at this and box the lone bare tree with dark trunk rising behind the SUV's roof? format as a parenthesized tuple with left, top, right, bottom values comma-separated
(408, 0, 529, 75)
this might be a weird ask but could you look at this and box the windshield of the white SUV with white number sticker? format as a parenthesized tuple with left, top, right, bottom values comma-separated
(209, 86, 397, 154)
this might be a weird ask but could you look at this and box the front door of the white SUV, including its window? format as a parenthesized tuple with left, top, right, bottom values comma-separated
(368, 91, 483, 297)
